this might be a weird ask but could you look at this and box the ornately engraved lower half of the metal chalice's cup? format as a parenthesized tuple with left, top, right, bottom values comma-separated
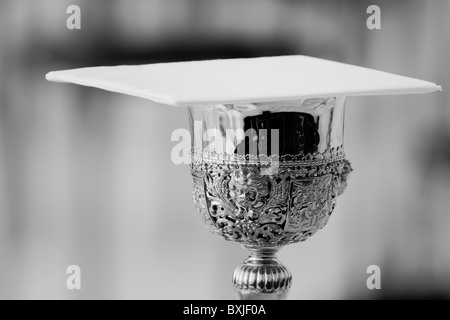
(191, 155, 352, 247)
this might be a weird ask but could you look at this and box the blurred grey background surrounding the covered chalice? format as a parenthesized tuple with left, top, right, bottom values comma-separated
(0, 0, 450, 299)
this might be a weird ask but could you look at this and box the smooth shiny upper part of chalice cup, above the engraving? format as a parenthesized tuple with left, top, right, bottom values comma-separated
(188, 97, 345, 159)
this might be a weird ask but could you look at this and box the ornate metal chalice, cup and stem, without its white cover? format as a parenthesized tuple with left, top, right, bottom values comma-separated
(188, 97, 352, 299)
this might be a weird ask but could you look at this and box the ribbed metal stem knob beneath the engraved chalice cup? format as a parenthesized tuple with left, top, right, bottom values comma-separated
(233, 245, 292, 300)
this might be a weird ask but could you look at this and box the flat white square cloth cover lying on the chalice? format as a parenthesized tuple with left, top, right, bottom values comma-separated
(46, 55, 441, 106)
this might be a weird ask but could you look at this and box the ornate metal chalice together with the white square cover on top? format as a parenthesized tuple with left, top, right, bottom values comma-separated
(47, 56, 441, 299)
